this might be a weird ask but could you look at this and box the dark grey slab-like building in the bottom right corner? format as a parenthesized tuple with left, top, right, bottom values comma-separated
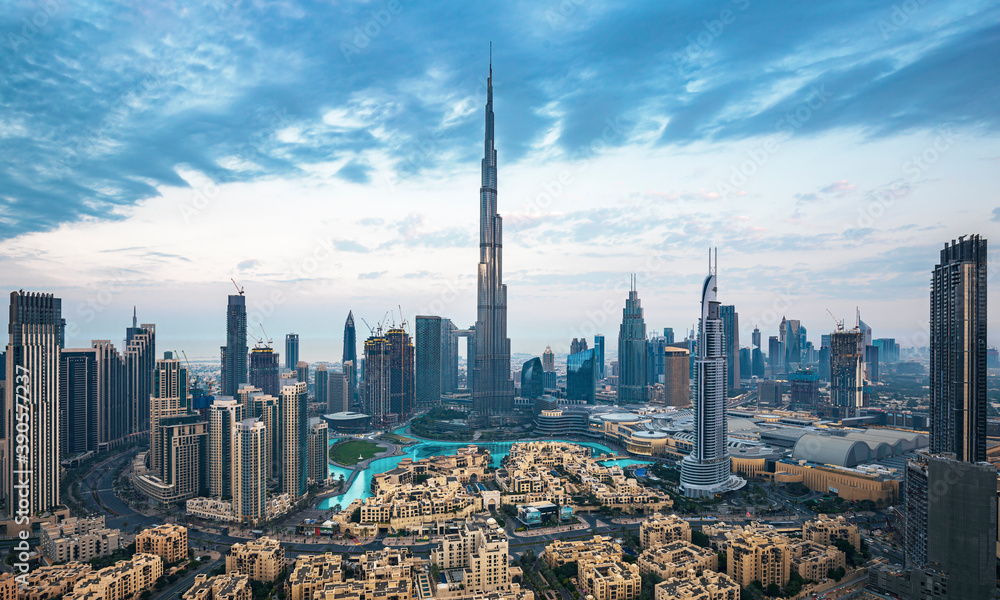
(903, 455, 997, 598)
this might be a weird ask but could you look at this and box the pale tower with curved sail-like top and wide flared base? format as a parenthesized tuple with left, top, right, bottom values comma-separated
(681, 258, 746, 498)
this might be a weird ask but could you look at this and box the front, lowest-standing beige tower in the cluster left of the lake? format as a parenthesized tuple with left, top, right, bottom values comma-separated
(233, 418, 268, 525)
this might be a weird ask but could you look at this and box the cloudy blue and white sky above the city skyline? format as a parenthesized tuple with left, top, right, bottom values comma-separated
(0, 0, 1000, 361)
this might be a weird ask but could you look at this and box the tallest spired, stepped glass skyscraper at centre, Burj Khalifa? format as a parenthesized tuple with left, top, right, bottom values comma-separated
(472, 64, 514, 416)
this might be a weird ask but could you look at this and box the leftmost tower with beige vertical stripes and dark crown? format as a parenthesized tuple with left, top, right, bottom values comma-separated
(2, 291, 64, 519)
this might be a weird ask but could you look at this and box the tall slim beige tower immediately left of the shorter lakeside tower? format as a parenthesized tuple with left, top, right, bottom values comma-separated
(278, 381, 309, 498)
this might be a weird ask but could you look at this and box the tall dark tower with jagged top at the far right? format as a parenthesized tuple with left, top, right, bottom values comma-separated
(930, 235, 987, 462)
